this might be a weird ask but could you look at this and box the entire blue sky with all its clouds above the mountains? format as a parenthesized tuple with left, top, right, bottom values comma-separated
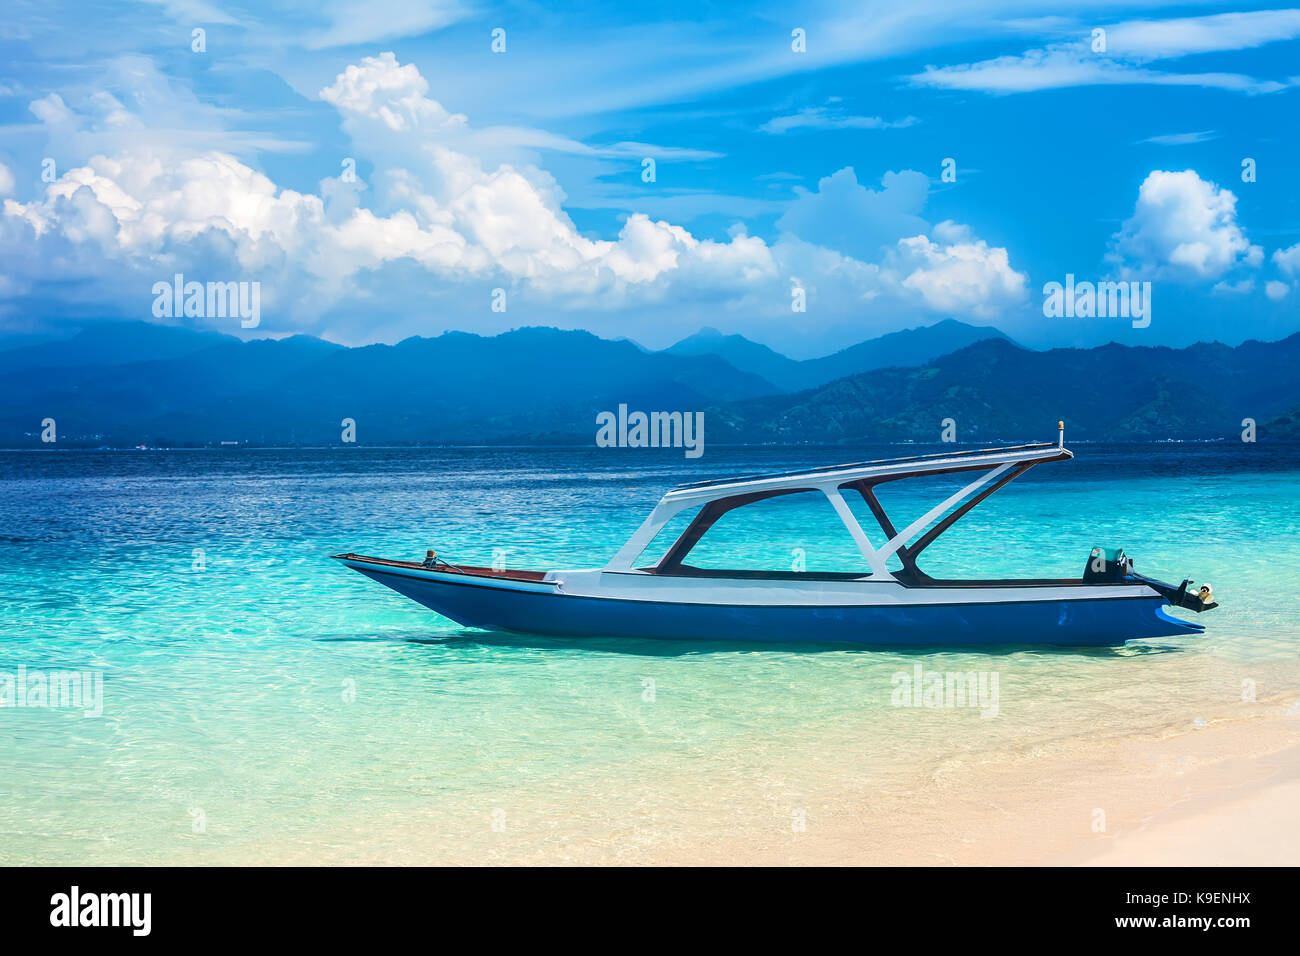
(0, 0, 1300, 356)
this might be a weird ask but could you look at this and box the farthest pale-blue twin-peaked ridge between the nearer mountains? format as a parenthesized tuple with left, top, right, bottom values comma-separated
(666, 319, 1006, 392)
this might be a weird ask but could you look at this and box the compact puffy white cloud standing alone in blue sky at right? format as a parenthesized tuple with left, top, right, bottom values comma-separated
(1112, 169, 1264, 281)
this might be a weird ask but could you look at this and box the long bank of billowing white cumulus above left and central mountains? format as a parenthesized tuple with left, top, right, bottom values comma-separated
(0, 53, 1024, 338)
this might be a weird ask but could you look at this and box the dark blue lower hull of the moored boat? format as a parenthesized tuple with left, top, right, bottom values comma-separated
(352, 564, 1204, 648)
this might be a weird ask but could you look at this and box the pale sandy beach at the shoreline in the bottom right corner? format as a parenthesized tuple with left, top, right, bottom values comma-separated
(759, 705, 1300, 866)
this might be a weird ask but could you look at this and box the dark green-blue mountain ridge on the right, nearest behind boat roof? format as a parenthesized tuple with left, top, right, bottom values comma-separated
(709, 333, 1300, 442)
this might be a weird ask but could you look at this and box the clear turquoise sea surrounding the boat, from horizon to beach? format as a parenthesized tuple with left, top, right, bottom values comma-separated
(0, 444, 1300, 864)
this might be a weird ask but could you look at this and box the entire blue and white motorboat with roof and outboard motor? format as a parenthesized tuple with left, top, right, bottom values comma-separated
(333, 423, 1218, 648)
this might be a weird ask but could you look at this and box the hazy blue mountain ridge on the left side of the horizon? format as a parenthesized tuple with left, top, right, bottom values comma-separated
(0, 323, 777, 446)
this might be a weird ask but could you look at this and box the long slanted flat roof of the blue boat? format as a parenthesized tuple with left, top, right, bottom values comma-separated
(666, 442, 1074, 497)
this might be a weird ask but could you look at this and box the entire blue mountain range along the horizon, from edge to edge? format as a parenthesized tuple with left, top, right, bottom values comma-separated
(0, 320, 1300, 447)
